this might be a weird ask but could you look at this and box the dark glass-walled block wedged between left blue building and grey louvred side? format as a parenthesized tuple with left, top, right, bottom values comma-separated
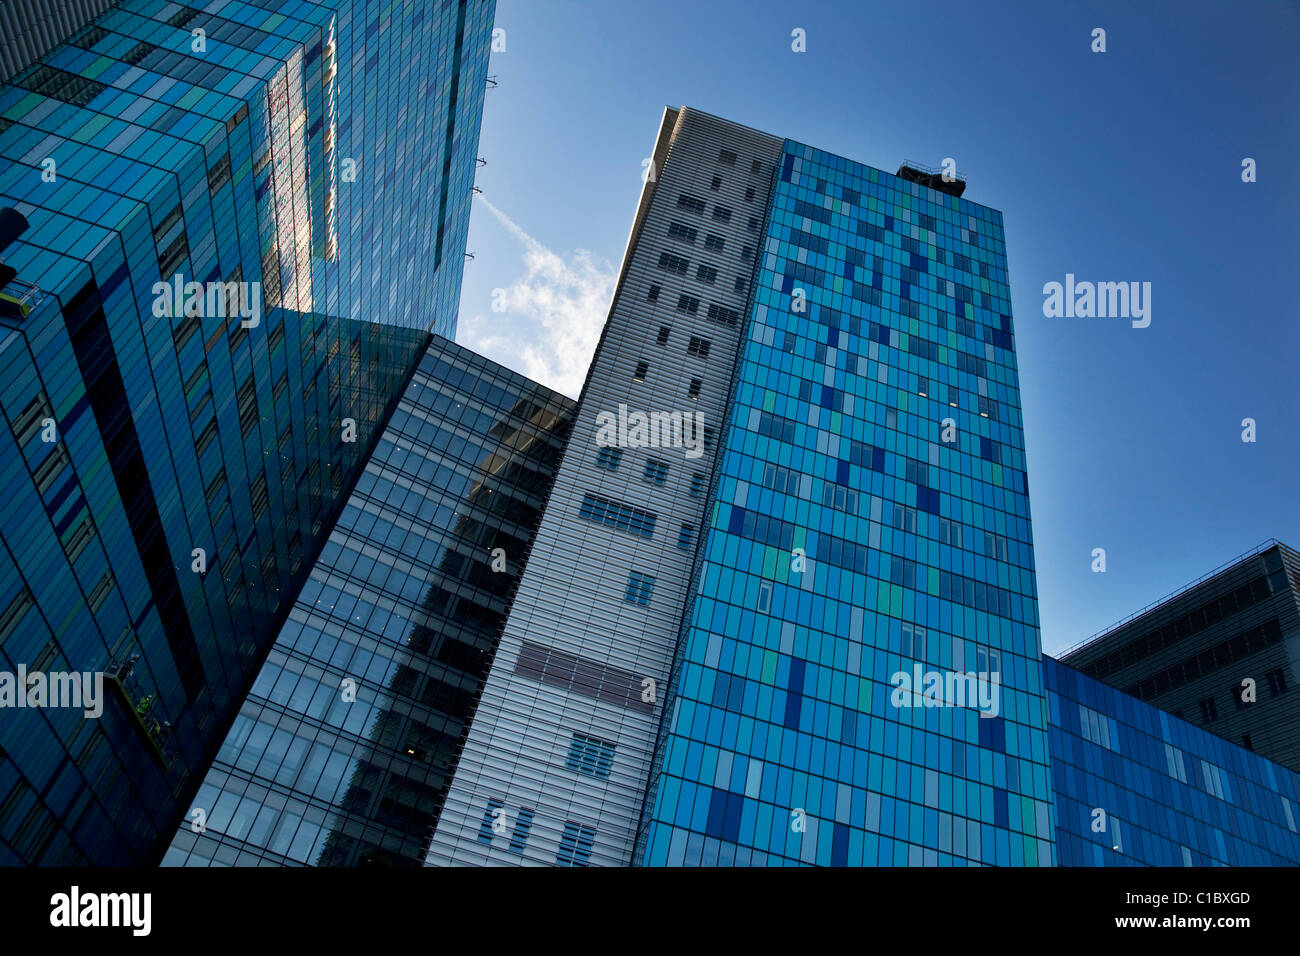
(164, 338, 575, 866)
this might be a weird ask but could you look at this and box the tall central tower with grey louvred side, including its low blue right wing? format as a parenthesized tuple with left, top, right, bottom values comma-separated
(428, 108, 1300, 865)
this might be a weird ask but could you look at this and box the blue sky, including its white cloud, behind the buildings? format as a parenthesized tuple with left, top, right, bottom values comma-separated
(458, 0, 1300, 653)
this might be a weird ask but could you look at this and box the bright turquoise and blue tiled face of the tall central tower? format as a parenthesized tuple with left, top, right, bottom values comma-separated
(641, 140, 1056, 865)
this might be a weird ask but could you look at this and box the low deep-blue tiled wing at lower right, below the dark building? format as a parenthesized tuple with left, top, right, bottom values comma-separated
(1043, 657, 1300, 866)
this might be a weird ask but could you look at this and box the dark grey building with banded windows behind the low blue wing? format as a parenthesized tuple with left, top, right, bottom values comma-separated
(1061, 541, 1300, 773)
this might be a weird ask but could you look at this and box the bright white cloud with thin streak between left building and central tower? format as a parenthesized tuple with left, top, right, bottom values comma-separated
(456, 195, 618, 398)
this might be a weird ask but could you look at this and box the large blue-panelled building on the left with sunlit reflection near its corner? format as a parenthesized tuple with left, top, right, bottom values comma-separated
(0, 0, 494, 864)
